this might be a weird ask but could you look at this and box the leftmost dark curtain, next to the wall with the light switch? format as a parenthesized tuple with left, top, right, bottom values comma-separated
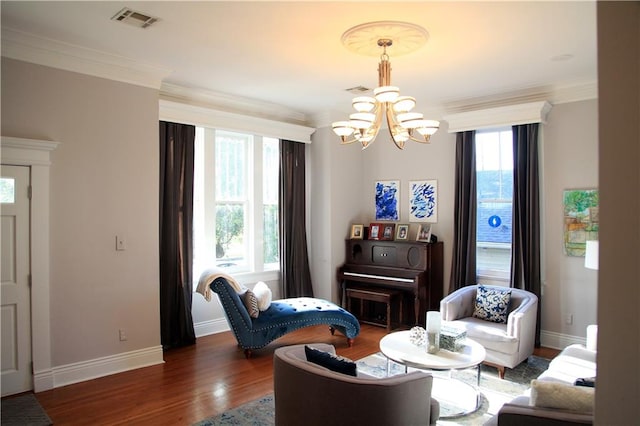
(160, 121, 196, 349)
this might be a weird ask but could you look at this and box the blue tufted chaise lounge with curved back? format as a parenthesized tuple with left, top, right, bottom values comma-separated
(202, 276, 360, 358)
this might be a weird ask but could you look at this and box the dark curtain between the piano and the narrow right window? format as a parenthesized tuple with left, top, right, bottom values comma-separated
(449, 130, 477, 293)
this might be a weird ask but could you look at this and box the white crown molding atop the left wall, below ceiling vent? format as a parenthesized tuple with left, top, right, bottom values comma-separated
(2, 27, 171, 89)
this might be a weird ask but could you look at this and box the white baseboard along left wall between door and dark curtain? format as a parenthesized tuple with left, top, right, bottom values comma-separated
(34, 346, 164, 392)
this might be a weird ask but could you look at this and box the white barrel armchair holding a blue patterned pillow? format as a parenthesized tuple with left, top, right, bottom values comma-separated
(440, 285, 538, 378)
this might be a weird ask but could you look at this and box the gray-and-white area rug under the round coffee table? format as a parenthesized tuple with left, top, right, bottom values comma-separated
(194, 353, 549, 426)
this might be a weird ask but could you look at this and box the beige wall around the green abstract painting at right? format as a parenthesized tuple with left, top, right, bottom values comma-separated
(542, 100, 598, 348)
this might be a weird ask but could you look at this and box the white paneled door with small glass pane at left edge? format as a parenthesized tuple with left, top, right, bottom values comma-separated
(0, 165, 33, 396)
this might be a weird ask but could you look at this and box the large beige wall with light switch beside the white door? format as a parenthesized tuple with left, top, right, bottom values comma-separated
(2, 58, 162, 370)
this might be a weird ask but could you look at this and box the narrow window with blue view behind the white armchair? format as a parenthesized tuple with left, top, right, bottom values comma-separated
(475, 128, 513, 284)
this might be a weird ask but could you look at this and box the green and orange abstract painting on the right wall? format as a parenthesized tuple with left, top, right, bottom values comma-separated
(562, 189, 599, 257)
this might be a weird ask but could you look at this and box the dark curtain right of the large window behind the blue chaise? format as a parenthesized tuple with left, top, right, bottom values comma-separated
(279, 140, 313, 298)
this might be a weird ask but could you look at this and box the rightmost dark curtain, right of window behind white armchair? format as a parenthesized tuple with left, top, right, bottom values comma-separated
(511, 123, 542, 346)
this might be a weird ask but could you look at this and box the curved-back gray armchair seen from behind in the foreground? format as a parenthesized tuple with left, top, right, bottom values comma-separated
(273, 343, 439, 426)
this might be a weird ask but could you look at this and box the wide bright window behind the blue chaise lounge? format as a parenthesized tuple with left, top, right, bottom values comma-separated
(193, 127, 280, 279)
